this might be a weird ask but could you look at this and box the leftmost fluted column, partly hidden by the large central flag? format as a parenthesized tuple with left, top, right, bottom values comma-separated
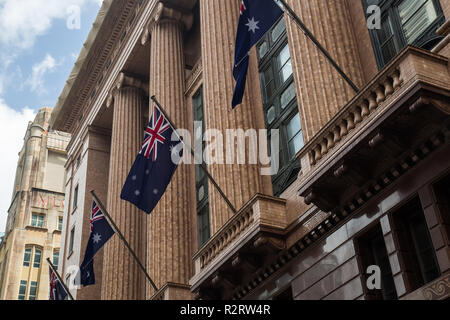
(102, 73, 147, 300)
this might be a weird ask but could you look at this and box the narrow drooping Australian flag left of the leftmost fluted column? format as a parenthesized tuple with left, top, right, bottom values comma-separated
(77, 201, 114, 286)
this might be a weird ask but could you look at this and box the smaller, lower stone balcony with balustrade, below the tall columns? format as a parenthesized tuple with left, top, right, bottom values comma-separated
(190, 194, 287, 299)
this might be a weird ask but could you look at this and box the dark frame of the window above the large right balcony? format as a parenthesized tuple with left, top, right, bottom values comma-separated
(361, 0, 445, 70)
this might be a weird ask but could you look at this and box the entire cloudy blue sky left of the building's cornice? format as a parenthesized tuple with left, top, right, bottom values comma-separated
(0, 0, 102, 232)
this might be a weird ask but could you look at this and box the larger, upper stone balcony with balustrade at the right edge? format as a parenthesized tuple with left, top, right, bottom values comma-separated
(297, 47, 450, 216)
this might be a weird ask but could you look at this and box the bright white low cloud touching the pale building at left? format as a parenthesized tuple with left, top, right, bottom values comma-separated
(0, 98, 35, 232)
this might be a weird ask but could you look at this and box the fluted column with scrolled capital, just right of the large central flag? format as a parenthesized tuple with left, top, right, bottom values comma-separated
(142, 2, 194, 299)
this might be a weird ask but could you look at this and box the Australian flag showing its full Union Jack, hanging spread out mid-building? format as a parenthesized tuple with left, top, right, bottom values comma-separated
(120, 106, 183, 214)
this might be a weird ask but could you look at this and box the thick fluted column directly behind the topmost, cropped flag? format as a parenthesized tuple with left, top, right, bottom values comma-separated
(200, 0, 263, 234)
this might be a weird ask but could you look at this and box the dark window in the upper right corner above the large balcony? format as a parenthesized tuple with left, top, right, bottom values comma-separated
(363, 0, 445, 68)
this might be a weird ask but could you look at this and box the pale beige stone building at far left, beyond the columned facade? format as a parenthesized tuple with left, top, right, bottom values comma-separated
(0, 108, 70, 300)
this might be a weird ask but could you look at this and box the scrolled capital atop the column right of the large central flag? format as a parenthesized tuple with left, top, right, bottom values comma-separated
(141, 1, 194, 45)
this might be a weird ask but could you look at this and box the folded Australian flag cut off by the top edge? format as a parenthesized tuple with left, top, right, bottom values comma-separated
(232, 0, 283, 108)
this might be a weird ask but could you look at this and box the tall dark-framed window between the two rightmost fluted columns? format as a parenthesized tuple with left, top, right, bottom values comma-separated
(257, 18, 304, 196)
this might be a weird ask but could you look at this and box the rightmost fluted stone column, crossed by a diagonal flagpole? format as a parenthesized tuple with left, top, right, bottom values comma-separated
(286, 0, 363, 141)
